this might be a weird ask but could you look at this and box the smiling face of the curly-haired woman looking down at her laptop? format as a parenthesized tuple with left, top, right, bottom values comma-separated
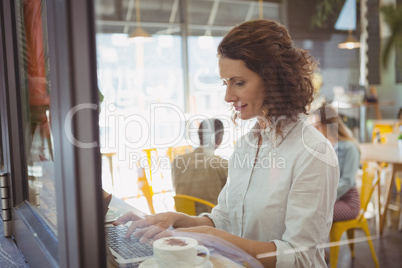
(219, 58, 265, 120)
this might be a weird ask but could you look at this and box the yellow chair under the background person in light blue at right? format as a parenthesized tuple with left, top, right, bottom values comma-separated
(329, 162, 381, 268)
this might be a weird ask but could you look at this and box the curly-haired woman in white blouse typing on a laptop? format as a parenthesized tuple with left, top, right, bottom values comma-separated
(115, 20, 339, 267)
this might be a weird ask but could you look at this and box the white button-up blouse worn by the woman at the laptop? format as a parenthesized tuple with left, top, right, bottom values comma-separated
(200, 119, 339, 268)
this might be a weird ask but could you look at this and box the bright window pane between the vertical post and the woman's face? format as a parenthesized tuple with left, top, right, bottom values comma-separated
(187, 0, 280, 157)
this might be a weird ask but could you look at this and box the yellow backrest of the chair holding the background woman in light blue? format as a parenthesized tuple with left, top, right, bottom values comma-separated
(360, 162, 380, 220)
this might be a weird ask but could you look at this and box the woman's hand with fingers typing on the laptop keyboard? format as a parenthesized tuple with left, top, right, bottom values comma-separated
(113, 212, 177, 242)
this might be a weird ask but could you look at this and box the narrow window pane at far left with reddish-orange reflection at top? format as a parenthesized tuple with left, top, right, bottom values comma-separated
(16, 0, 57, 233)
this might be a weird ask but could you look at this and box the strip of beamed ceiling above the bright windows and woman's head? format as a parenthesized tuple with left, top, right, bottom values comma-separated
(95, 0, 281, 36)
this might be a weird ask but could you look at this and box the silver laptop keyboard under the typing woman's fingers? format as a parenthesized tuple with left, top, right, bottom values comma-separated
(105, 225, 153, 260)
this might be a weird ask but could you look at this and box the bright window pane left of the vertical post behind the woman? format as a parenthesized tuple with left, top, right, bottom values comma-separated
(95, 0, 185, 197)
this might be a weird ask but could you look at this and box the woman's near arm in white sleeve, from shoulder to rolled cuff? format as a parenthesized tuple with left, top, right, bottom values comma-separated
(272, 142, 339, 267)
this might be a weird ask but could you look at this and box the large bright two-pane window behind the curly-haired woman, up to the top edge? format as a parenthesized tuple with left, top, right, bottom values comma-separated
(95, 0, 279, 209)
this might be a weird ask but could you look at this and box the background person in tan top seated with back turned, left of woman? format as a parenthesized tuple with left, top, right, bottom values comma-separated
(172, 119, 228, 214)
